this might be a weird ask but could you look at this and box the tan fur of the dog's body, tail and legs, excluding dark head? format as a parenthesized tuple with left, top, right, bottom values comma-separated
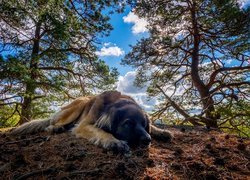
(8, 91, 172, 148)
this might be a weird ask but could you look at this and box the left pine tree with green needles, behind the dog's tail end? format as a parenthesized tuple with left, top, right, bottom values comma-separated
(0, 0, 122, 124)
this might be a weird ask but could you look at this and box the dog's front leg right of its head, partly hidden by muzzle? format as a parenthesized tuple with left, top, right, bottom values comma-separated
(150, 124, 173, 142)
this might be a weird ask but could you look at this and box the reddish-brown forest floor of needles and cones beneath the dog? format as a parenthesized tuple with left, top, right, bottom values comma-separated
(0, 128, 250, 180)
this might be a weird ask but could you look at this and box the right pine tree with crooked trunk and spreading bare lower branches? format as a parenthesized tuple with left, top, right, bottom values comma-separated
(123, 0, 250, 127)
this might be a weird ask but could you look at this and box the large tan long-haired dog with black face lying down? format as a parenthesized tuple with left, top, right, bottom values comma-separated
(10, 91, 172, 152)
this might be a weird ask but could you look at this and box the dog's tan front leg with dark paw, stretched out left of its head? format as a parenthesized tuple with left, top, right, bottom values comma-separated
(73, 124, 129, 153)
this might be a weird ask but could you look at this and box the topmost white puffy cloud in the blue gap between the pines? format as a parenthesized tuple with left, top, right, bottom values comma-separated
(123, 12, 148, 34)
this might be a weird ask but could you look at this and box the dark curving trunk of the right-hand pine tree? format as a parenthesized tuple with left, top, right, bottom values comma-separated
(190, 2, 218, 128)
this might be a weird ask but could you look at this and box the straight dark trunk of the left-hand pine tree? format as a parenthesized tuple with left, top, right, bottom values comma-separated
(18, 22, 41, 124)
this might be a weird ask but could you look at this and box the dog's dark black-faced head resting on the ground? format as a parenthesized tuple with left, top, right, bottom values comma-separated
(97, 98, 151, 146)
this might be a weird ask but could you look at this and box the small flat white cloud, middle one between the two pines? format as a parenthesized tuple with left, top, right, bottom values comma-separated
(95, 43, 125, 56)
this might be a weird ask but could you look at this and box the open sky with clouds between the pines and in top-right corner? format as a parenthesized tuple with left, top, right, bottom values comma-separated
(96, 0, 250, 111)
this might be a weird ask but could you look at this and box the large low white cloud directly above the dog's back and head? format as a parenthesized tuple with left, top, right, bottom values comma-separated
(117, 71, 157, 111)
